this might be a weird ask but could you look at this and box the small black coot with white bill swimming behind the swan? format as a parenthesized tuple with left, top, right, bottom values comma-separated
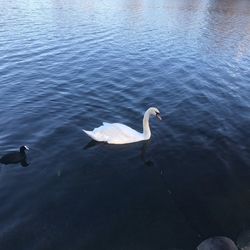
(0, 146, 29, 166)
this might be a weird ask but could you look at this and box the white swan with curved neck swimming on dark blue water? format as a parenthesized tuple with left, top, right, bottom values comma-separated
(83, 107, 161, 144)
